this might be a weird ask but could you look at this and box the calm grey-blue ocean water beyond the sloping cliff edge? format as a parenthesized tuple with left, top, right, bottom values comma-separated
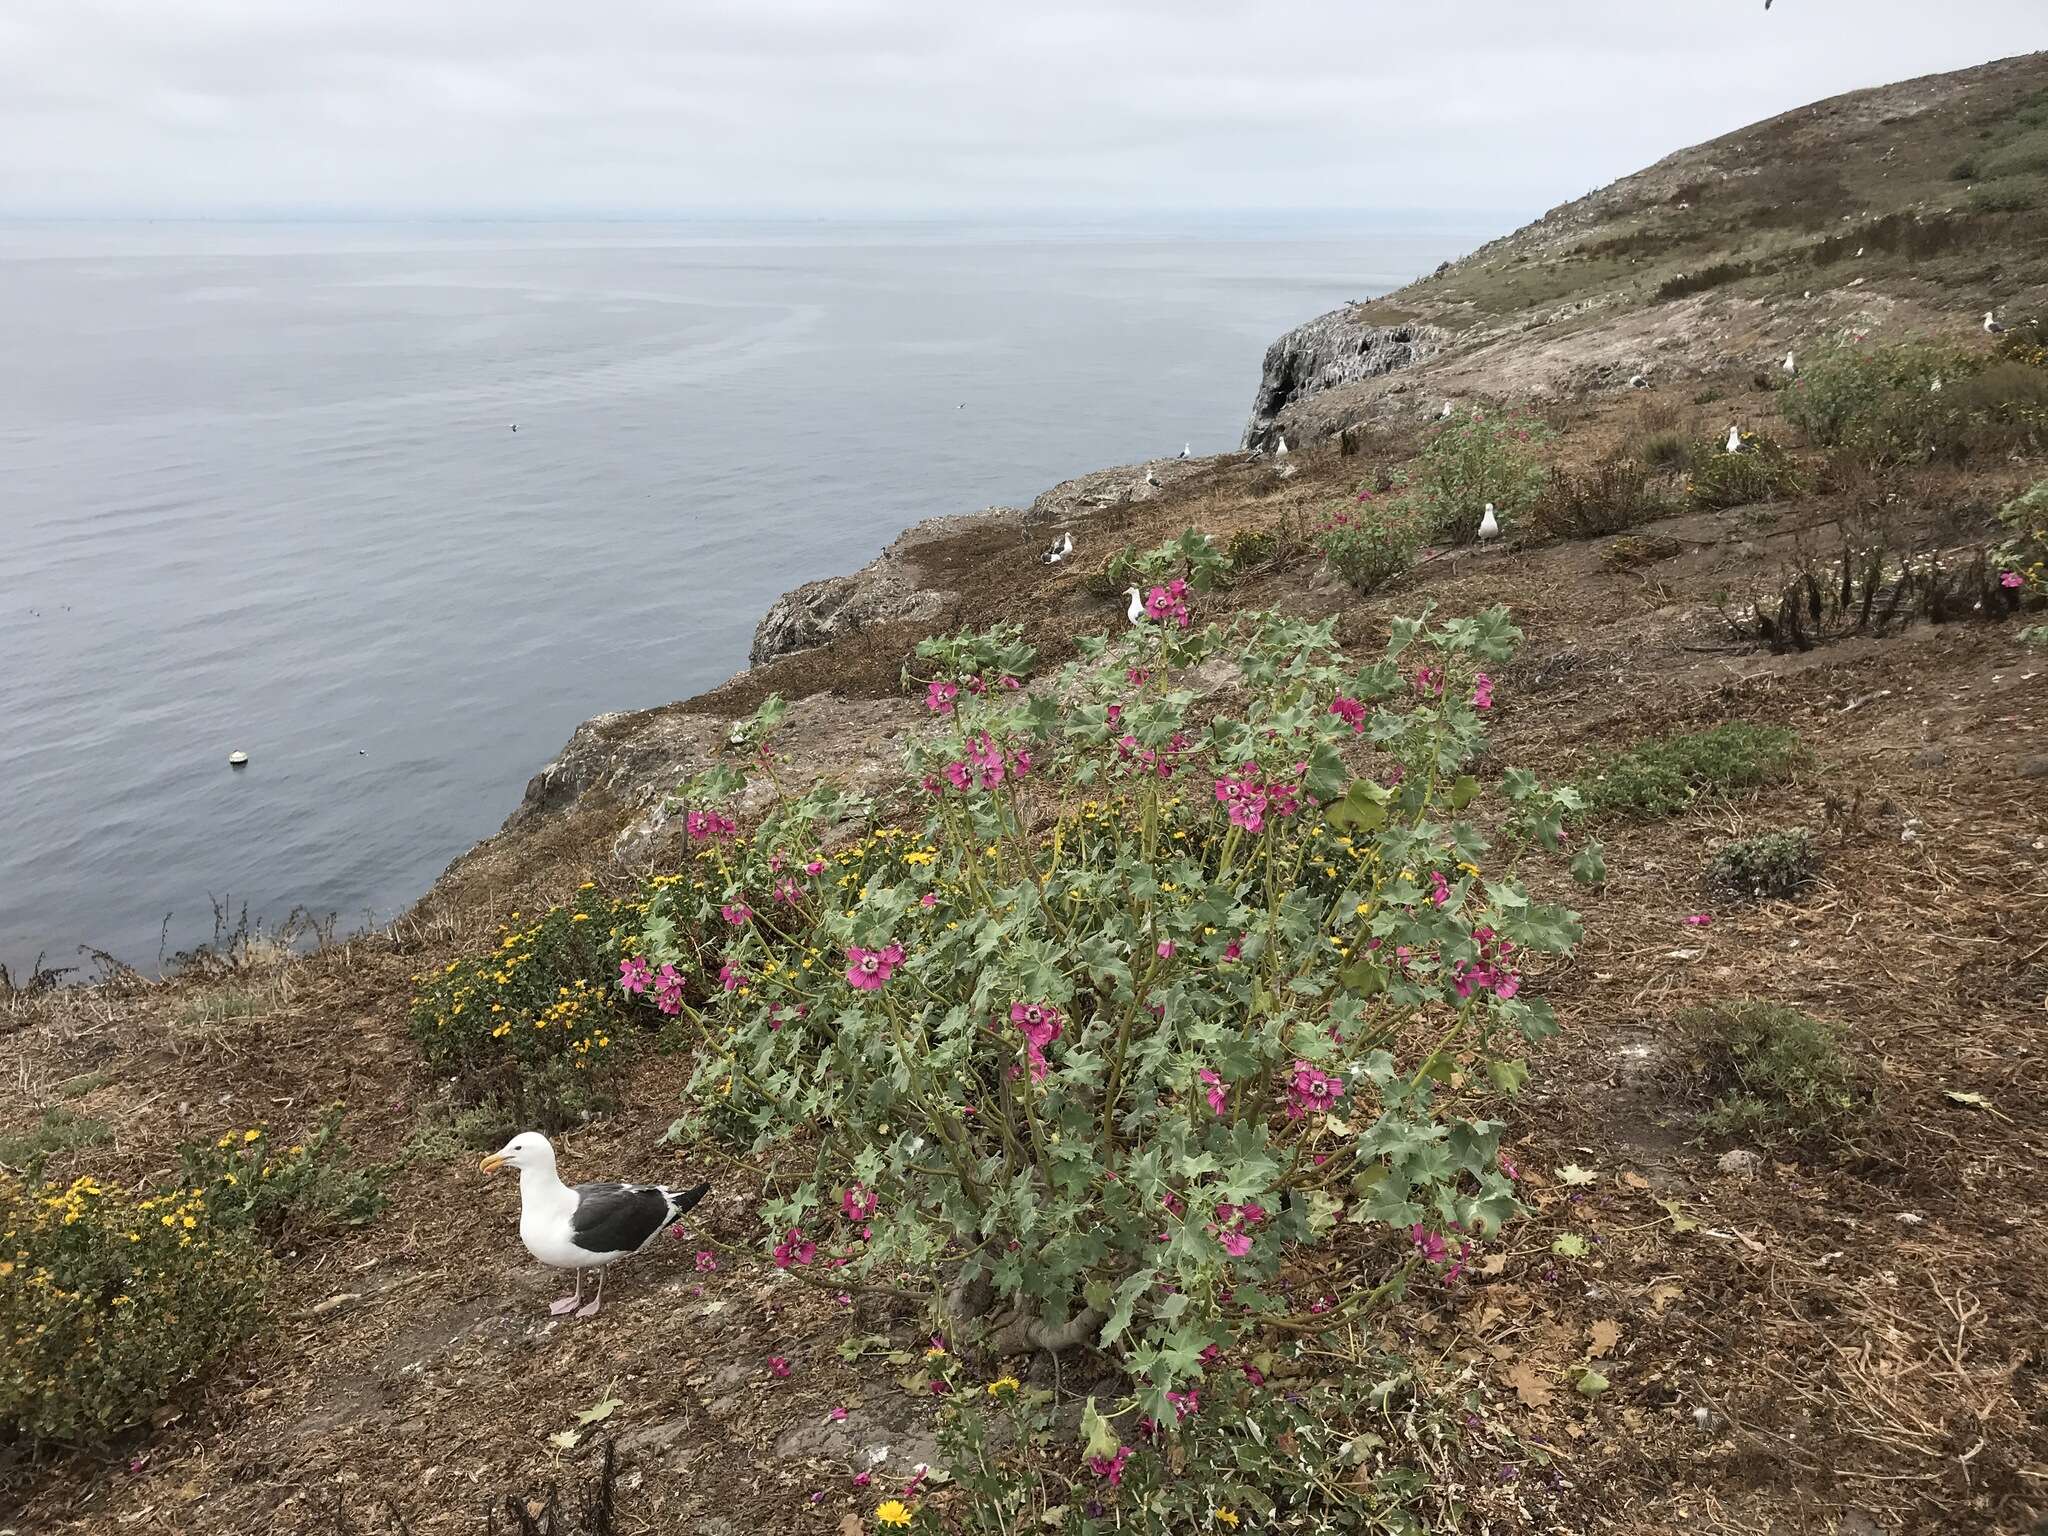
(0, 221, 1491, 975)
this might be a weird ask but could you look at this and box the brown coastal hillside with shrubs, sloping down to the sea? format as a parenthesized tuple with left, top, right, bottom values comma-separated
(0, 53, 2048, 1536)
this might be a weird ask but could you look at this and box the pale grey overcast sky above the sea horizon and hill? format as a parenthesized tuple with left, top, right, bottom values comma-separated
(0, 0, 2048, 215)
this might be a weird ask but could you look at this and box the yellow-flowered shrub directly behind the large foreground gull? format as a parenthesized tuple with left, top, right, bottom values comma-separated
(412, 884, 638, 1130)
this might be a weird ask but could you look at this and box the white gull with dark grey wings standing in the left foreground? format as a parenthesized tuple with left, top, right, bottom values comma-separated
(477, 1130, 711, 1317)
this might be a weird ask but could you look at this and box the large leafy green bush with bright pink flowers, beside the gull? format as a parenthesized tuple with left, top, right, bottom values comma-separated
(637, 593, 1597, 1458)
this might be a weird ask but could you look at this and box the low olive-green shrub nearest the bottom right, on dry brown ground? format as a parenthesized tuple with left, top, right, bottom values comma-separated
(1679, 1001, 1874, 1141)
